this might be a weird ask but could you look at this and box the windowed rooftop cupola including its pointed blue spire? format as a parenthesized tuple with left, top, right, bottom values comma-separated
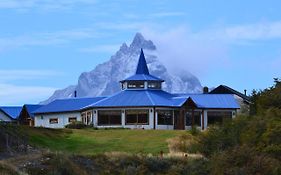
(120, 49, 164, 90)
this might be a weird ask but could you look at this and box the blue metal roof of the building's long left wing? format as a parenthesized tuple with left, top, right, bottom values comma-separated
(33, 97, 105, 114)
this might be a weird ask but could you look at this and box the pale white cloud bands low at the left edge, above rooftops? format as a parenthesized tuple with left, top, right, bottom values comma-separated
(0, 70, 63, 105)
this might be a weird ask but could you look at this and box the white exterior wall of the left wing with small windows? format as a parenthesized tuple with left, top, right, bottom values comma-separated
(34, 112, 81, 128)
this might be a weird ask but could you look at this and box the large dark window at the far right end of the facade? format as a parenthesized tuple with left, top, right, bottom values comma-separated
(207, 111, 232, 124)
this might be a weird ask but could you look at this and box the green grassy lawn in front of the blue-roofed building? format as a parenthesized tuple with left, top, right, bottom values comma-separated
(26, 128, 186, 155)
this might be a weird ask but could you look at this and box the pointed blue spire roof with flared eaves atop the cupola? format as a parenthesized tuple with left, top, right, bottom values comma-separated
(121, 49, 164, 82)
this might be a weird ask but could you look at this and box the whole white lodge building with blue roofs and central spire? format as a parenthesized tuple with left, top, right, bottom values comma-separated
(33, 50, 240, 130)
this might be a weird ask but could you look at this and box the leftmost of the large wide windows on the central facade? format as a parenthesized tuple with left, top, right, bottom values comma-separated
(98, 110, 122, 125)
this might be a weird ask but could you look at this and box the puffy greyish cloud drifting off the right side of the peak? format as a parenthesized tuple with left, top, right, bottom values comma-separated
(143, 27, 228, 75)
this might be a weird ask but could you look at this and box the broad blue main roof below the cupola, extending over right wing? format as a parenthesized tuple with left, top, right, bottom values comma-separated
(85, 90, 239, 109)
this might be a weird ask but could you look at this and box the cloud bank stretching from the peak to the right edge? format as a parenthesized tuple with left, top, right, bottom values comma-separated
(141, 21, 281, 76)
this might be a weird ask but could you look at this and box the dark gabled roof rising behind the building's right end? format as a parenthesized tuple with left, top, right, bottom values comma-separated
(209, 85, 251, 103)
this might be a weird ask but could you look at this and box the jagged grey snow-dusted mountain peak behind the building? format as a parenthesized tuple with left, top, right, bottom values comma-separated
(41, 33, 202, 103)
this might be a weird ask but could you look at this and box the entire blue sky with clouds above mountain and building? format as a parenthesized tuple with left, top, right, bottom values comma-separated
(0, 0, 281, 105)
